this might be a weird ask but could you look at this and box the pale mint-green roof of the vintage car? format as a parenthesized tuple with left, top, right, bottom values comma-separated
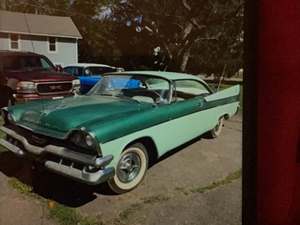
(109, 71, 206, 83)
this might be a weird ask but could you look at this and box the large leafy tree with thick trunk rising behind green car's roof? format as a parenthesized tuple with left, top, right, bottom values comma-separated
(113, 0, 242, 74)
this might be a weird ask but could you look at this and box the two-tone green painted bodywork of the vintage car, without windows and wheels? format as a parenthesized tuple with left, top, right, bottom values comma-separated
(0, 71, 240, 191)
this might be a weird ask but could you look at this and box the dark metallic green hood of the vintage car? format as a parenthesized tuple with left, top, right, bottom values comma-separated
(10, 96, 153, 134)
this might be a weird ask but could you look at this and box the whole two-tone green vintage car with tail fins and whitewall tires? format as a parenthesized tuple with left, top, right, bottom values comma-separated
(0, 71, 240, 193)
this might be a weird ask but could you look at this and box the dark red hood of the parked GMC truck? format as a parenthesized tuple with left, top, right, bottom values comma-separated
(6, 70, 76, 82)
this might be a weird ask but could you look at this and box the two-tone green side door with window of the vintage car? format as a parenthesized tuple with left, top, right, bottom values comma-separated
(162, 79, 211, 146)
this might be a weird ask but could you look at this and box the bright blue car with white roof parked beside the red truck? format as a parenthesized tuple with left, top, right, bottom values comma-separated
(64, 63, 124, 94)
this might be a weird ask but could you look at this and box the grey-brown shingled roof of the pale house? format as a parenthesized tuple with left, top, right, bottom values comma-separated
(0, 10, 82, 39)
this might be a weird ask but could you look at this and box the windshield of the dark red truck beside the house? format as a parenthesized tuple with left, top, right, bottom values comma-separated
(2, 56, 54, 71)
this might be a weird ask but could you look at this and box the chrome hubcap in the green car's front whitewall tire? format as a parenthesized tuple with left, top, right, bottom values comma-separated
(117, 152, 141, 183)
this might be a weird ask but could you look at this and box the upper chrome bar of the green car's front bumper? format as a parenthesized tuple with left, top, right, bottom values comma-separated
(0, 126, 113, 168)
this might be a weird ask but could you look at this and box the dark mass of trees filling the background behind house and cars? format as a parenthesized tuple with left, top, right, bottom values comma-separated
(2, 0, 243, 75)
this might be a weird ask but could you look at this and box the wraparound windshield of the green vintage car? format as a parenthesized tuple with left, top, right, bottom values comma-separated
(88, 74, 170, 104)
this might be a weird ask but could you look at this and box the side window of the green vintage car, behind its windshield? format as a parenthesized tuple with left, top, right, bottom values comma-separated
(173, 80, 210, 100)
